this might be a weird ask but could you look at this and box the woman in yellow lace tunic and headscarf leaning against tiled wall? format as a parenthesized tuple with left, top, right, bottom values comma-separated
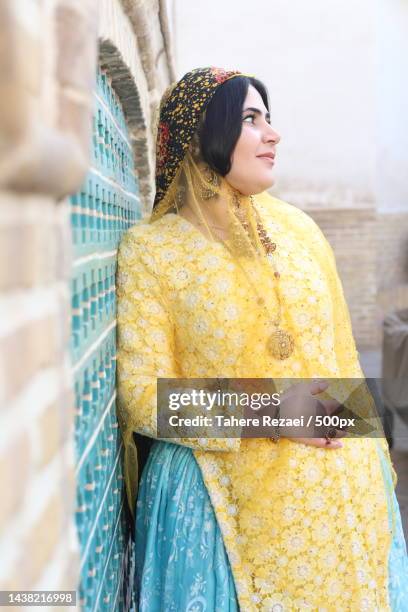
(118, 68, 408, 612)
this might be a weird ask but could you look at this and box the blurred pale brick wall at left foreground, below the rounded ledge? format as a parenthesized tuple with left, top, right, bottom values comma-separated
(0, 192, 77, 589)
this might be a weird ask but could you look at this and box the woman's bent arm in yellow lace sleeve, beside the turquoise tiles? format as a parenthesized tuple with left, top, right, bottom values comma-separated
(117, 228, 240, 451)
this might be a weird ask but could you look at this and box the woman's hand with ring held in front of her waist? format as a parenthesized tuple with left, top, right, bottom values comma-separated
(280, 381, 345, 450)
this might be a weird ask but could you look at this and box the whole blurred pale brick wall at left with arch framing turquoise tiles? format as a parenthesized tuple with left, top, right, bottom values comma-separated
(0, 0, 173, 589)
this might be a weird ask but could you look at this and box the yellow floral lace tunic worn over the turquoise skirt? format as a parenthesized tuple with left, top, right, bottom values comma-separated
(117, 194, 395, 612)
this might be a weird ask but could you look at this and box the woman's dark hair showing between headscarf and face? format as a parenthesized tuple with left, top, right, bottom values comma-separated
(198, 76, 269, 176)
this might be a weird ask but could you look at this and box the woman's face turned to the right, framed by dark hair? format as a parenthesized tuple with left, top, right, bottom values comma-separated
(225, 85, 280, 195)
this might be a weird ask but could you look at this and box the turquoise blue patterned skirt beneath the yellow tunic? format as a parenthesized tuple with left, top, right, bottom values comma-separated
(135, 441, 408, 612)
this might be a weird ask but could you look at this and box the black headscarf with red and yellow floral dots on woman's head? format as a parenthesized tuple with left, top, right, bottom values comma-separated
(154, 67, 244, 213)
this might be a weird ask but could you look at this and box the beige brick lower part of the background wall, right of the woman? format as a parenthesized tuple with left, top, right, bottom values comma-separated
(307, 205, 408, 349)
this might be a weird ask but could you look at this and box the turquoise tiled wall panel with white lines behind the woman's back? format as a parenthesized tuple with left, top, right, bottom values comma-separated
(71, 71, 141, 612)
